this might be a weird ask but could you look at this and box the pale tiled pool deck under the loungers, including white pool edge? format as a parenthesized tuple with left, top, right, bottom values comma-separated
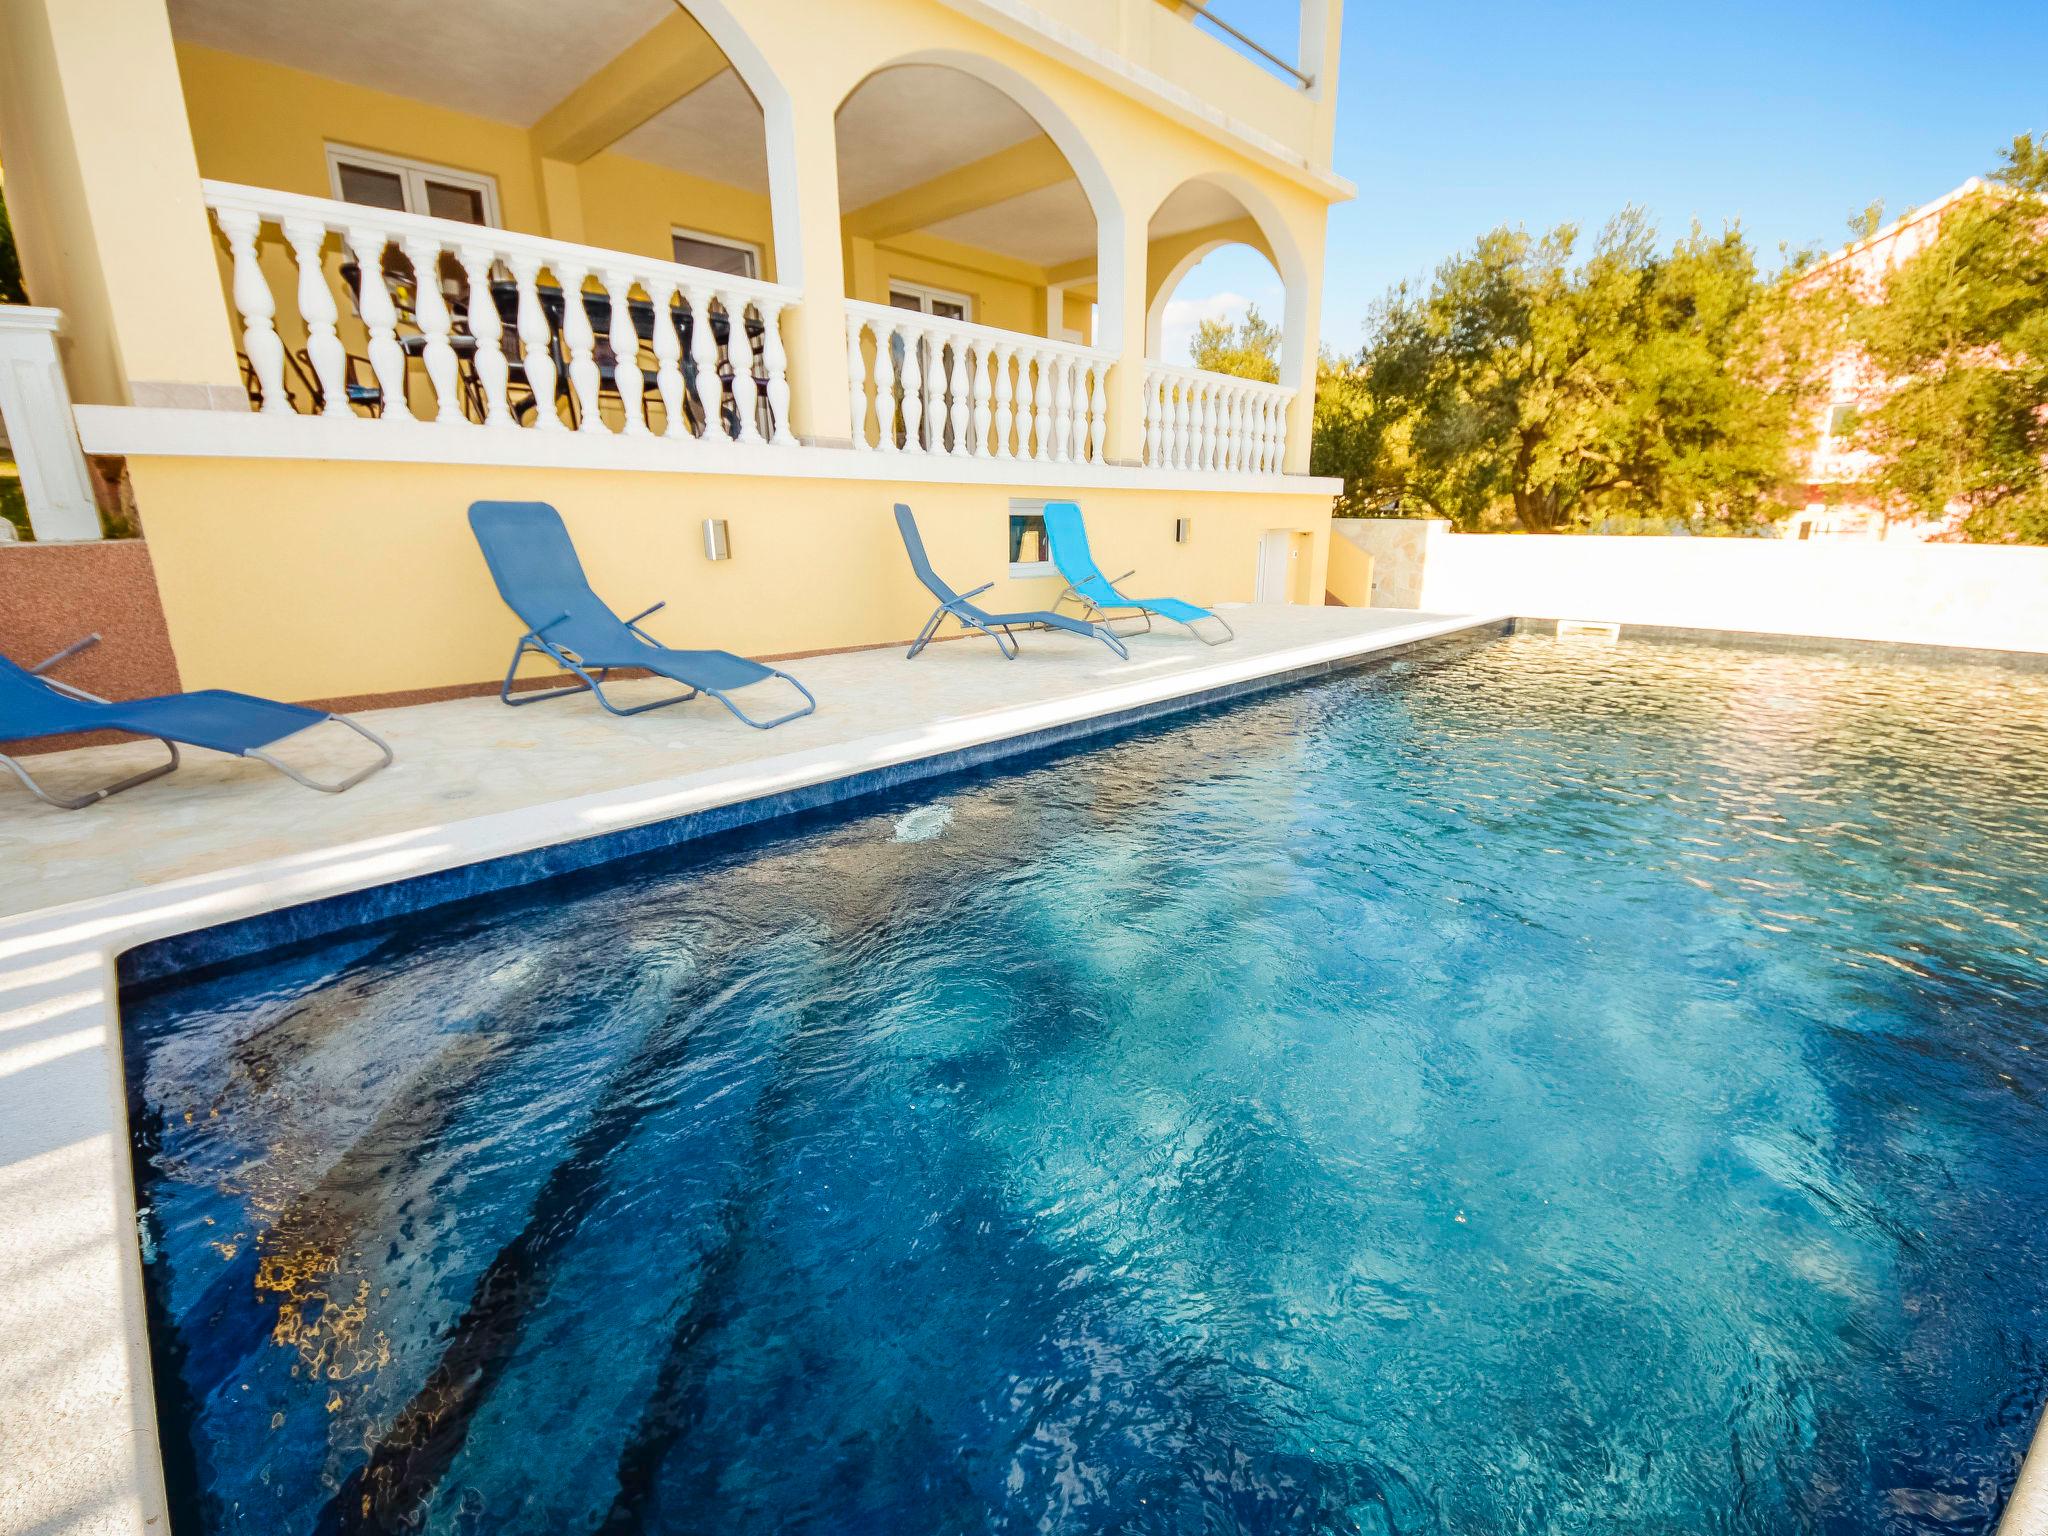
(0, 608, 2048, 1536)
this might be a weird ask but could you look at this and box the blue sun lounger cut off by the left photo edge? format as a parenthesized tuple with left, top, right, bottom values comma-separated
(0, 635, 391, 811)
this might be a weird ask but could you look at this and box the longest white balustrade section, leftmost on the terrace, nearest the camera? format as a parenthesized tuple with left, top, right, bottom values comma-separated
(203, 180, 798, 446)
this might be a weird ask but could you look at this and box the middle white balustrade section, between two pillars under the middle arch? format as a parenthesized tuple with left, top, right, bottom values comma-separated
(846, 301, 1114, 463)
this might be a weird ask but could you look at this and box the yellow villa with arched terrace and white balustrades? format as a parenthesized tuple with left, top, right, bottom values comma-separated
(0, 0, 1350, 700)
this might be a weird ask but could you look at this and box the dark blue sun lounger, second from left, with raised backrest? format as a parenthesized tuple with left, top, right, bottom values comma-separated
(469, 502, 817, 731)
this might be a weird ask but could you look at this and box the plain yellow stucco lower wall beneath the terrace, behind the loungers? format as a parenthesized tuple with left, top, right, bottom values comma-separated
(129, 459, 1329, 698)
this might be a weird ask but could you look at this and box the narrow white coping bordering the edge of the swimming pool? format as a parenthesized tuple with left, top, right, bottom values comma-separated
(0, 614, 2048, 1536)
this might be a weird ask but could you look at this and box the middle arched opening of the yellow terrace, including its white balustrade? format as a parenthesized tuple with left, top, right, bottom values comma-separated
(834, 55, 1116, 461)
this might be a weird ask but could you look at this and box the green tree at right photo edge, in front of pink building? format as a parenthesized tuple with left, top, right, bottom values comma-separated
(1851, 135, 2048, 545)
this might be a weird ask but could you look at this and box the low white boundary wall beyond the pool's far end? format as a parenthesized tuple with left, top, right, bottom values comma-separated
(1333, 518, 2048, 651)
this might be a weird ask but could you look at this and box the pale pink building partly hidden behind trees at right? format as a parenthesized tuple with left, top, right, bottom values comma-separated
(1784, 176, 1985, 543)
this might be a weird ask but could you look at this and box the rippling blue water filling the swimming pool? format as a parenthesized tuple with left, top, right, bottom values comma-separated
(125, 635, 2048, 1536)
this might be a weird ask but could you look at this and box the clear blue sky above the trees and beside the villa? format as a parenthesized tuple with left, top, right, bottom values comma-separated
(1167, 0, 2048, 364)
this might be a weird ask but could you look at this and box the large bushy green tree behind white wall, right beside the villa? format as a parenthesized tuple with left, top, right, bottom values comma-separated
(1315, 209, 1825, 532)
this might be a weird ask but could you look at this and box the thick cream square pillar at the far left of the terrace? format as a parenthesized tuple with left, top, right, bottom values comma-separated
(0, 0, 248, 410)
